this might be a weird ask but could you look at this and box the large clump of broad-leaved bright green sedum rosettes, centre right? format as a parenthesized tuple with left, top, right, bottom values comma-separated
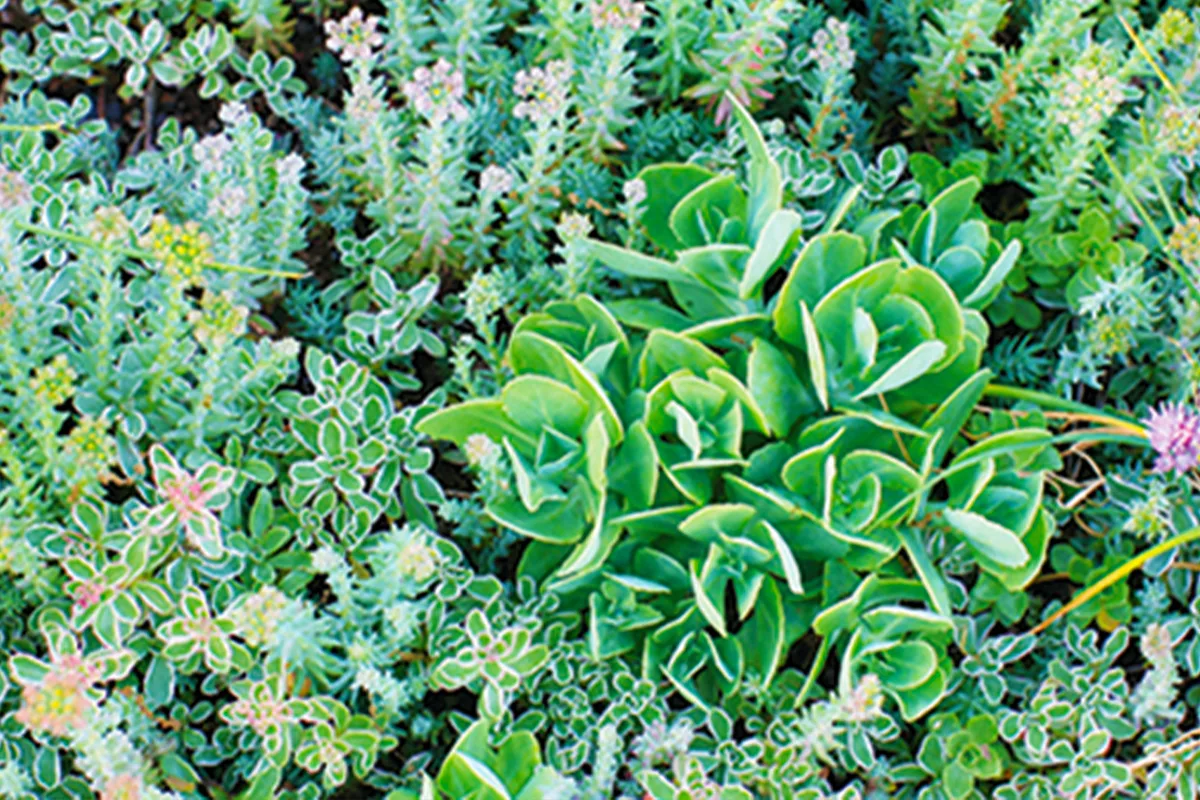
(418, 98, 1056, 720)
